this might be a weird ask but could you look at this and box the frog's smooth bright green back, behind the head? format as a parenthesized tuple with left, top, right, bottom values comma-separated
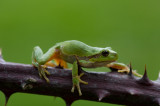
(59, 40, 99, 57)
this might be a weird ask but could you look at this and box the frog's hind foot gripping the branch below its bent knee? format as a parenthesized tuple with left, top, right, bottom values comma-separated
(32, 62, 50, 83)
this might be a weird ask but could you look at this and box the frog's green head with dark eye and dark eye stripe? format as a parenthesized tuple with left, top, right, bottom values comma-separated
(89, 47, 118, 63)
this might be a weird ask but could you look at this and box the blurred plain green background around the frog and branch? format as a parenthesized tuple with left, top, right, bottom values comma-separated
(0, 0, 160, 106)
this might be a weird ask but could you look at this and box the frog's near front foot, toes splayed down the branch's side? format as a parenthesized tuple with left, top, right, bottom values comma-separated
(71, 73, 88, 96)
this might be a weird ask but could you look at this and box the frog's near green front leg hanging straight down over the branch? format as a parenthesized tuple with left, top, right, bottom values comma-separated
(71, 61, 88, 96)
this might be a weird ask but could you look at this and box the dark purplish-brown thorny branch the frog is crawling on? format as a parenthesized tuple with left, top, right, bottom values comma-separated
(0, 49, 160, 106)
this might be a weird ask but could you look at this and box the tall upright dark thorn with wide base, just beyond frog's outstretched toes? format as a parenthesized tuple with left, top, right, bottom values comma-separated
(138, 65, 152, 86)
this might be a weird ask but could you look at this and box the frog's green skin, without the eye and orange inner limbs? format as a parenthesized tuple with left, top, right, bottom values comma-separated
(32, 40, 118, 95)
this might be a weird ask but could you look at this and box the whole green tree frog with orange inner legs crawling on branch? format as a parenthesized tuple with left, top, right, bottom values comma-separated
(32, 40, 141, 95)
